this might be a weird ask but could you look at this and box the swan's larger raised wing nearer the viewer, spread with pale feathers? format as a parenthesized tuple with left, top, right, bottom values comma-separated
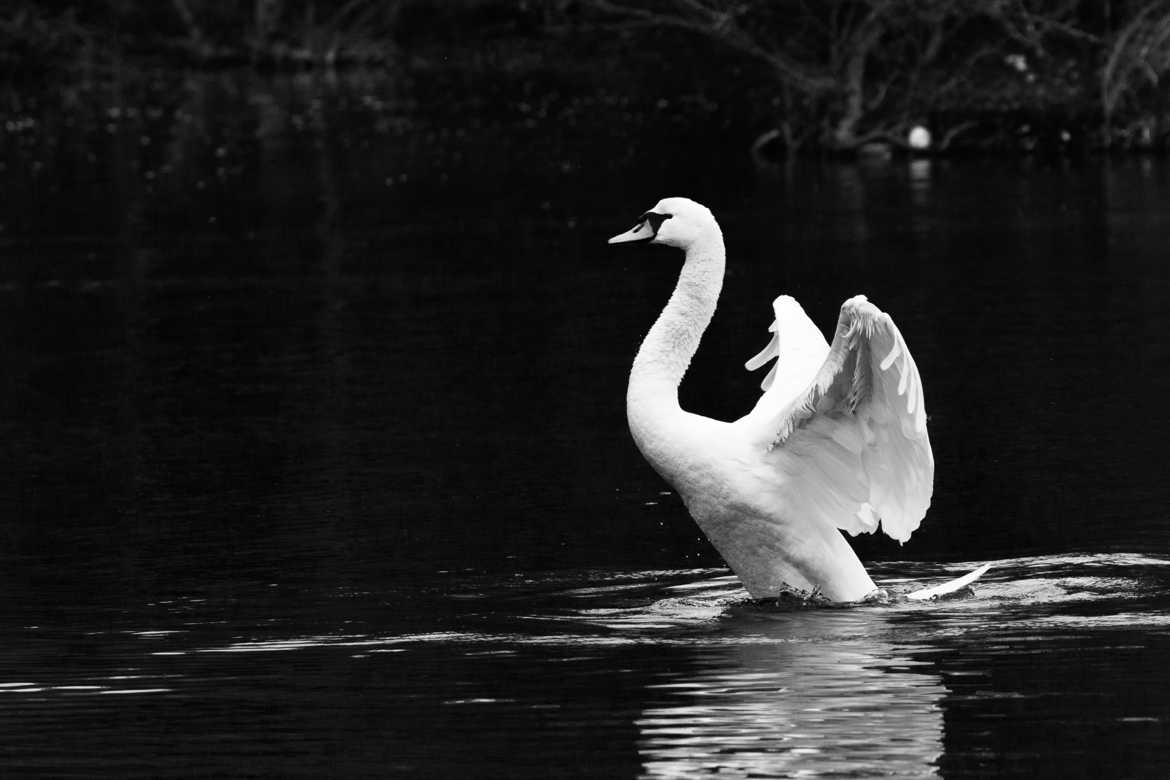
(745, 296, 935, 541)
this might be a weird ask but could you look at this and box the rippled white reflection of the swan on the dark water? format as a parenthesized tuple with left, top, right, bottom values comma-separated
(636, 610, 947, 778)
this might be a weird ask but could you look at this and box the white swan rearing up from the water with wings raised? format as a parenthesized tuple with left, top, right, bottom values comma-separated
(611, 198, 934, 601)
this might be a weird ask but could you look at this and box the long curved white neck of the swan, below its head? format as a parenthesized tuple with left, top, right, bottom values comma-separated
(626, 235, 725, 430)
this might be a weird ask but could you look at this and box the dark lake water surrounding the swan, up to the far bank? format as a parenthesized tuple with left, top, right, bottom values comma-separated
(0, 74, 1170, 778)
